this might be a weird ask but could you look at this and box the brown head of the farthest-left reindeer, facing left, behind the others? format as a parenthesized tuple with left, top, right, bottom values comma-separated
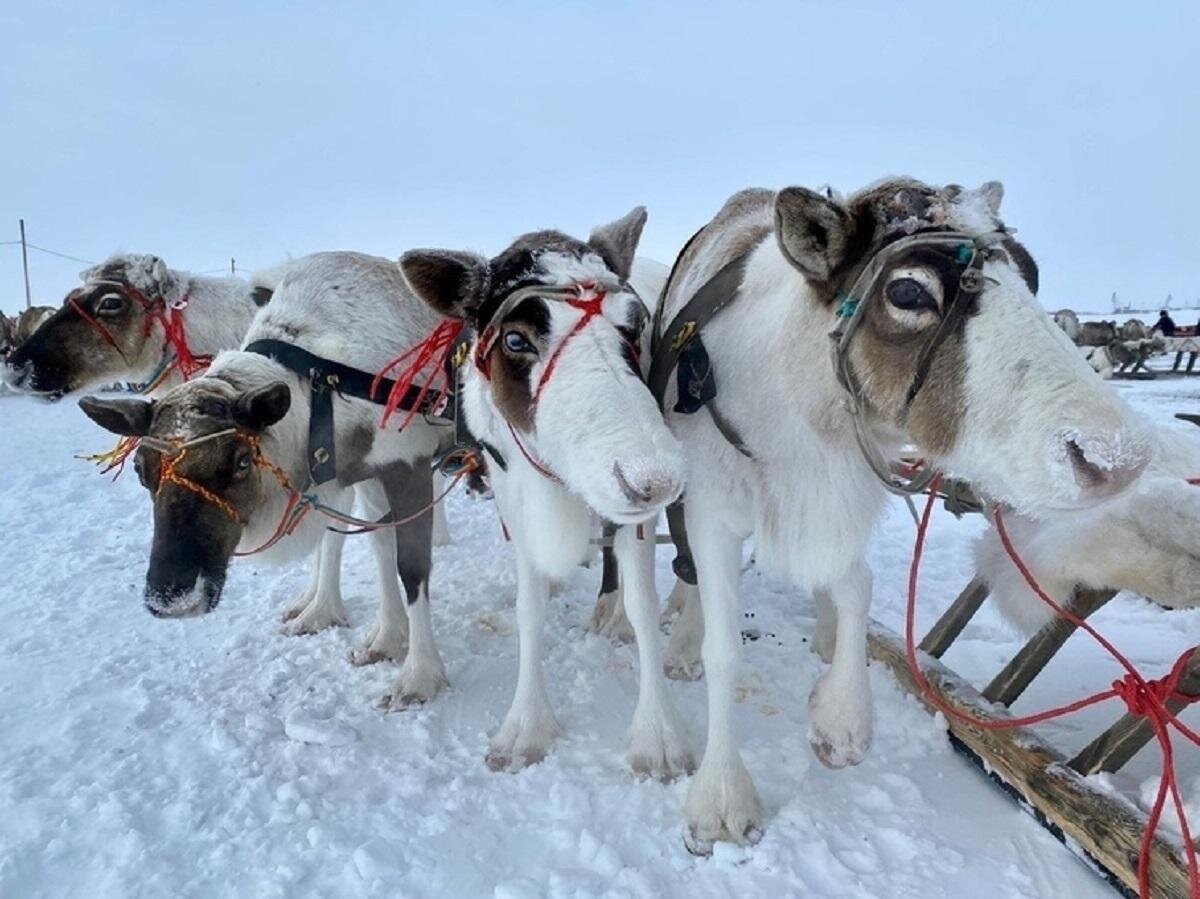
(5, 254, 187, 398)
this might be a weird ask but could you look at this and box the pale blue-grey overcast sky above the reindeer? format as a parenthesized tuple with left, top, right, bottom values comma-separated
(0, 0, 1200, 311)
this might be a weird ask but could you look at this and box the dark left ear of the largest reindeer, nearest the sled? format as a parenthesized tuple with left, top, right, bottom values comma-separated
(775, 187, 854, 282)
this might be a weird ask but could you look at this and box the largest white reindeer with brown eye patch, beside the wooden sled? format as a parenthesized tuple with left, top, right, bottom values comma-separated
(650, 179, 1150, 853)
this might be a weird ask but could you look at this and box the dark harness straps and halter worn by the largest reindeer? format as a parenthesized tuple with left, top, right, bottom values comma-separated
(647, 220, 1006, 585)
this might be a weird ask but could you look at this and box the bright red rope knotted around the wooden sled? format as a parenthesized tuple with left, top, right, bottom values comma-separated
(905, 475, 1200, 899)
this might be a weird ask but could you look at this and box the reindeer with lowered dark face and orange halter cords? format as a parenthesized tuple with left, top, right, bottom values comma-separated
(80, 252, 446, 708)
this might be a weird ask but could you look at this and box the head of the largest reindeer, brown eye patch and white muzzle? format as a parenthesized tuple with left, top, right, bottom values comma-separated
(775, 180, 1150, 511)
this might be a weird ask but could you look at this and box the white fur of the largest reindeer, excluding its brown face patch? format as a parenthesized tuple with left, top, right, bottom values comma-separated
(665, 180, 1148, 852)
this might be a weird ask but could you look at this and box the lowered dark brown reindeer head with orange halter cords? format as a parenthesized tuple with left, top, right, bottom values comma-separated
(79, 377, 292, 617)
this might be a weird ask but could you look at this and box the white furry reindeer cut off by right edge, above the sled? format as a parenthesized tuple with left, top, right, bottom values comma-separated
(974, 427, 1200, 633)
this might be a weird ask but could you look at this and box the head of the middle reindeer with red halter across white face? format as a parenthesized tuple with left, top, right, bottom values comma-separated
(400, 208, 683, 523)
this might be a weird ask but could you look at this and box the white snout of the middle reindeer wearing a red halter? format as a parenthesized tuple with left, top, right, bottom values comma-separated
(534, 320, 684, 525)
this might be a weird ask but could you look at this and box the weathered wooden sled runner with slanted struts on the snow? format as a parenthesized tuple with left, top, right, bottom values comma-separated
(869, 579, 1200, 899)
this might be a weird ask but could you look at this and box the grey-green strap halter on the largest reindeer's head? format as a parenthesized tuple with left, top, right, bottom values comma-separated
(829, 230, 1007, 497)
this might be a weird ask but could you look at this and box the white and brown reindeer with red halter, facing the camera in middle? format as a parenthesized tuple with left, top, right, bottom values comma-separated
(401, 209, 692, 778)
